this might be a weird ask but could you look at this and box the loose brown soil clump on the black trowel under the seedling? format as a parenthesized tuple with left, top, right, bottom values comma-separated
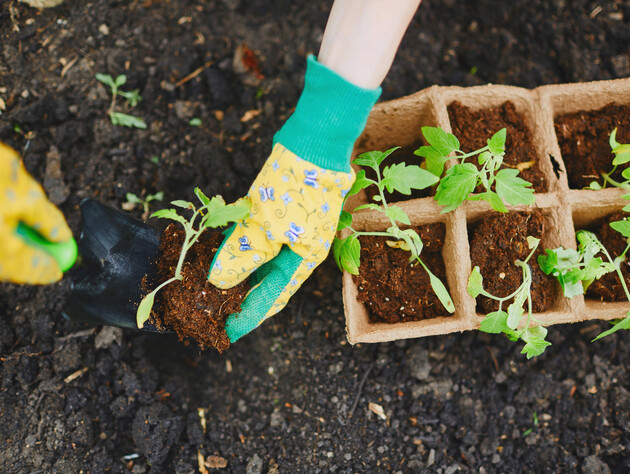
(154, 224, 249, 352)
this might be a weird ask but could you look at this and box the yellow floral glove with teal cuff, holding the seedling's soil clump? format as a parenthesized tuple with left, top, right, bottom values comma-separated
(209, 56, 381, 342)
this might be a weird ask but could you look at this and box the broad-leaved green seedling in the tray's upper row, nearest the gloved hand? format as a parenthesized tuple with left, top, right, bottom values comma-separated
(415, 127, 535, 212)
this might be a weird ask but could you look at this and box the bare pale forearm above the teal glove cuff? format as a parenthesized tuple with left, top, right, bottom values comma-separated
(318, 0, 420, 89)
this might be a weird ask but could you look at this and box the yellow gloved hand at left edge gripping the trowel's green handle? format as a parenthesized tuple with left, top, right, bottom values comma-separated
(0, 143, 72, 284)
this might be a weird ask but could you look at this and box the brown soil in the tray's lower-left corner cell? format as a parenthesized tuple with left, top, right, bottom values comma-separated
(354, 223, 450, 323)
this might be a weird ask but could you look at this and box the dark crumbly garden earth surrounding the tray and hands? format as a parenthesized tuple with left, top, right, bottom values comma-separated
(0, 0, 630, 474)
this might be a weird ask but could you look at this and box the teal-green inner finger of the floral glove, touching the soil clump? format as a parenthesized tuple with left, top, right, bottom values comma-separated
(225, 246, 302, 342)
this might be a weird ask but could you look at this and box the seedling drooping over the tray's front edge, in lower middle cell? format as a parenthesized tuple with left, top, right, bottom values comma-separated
(468, 236, 551, 359)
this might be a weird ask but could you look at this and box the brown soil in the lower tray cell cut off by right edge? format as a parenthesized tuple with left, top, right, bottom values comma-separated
(586, 212, 630, 301)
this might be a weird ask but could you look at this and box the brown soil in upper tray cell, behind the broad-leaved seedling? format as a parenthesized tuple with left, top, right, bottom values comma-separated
(448, 101, 547, 193)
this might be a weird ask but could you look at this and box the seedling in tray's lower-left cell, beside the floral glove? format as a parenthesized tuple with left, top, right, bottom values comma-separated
(333, 147, 455, 313)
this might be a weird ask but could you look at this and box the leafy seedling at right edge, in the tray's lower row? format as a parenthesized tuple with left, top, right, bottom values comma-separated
(538, 226, 630, 341)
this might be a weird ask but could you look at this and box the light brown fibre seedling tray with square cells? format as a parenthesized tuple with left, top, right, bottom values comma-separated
(343, 79, 630, 344)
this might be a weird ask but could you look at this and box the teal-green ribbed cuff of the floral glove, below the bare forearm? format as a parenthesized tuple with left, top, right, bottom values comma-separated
(273, 55, 381, 173)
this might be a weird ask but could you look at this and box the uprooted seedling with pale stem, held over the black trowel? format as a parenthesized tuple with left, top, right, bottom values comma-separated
(136, 188, 251, 328)
